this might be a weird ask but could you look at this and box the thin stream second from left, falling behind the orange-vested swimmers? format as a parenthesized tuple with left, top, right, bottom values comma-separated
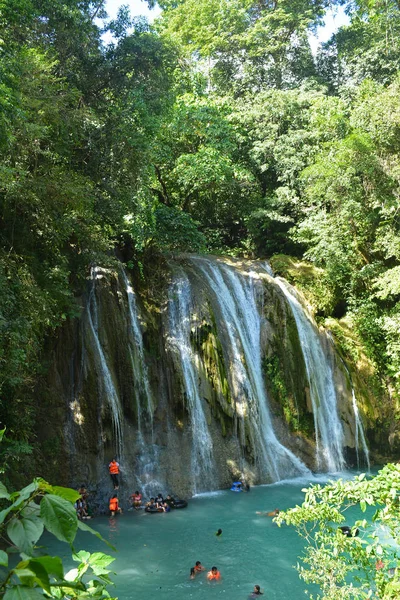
(121, 269, 164, 497)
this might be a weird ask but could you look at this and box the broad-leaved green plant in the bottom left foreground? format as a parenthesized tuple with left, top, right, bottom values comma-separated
(0, 464, 114, 600)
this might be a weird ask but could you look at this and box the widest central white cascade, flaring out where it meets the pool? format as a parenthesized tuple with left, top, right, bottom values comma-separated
(191, 257, 309, 481)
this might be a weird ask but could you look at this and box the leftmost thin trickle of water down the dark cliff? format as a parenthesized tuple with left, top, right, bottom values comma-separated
(87, 267, 123, 457)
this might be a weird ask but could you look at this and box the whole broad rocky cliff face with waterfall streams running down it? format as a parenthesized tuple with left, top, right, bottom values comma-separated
(38, 256, 376, 508)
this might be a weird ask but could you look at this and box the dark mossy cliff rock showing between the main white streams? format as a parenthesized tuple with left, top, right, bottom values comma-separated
(33, 256, 390, 508)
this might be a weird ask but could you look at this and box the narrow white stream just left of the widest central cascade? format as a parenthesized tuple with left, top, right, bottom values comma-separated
(167, 275, 215, 493)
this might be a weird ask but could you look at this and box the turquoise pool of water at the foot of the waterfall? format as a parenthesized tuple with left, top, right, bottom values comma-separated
(46, 478, 354, 600)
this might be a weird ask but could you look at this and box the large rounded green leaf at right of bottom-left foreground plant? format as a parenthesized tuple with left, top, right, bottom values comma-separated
(40, 494, 78, 544)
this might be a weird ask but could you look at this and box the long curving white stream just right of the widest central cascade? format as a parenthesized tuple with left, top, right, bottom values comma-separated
(265, 269, 345, 472)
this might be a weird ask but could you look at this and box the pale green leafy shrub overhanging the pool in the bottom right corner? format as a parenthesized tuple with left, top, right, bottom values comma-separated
(275, 464, 400, 600)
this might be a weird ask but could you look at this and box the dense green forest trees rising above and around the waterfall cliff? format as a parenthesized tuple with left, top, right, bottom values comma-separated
(0, 0, 400, 478)
